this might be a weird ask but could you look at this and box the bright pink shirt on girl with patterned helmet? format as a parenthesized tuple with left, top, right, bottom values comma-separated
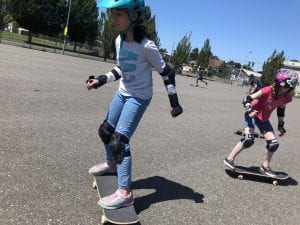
(251, 86, 293, 122)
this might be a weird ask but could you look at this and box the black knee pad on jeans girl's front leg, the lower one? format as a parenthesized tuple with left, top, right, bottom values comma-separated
(109, 132, 130, 163)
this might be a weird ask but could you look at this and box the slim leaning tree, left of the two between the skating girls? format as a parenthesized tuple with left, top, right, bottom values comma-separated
(171, 33, 192, 73)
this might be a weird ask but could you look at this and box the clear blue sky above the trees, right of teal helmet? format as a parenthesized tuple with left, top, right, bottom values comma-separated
(145, 0, 300, 70)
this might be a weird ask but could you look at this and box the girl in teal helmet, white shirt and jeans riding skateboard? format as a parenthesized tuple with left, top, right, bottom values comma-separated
(86, 0, 183, 209)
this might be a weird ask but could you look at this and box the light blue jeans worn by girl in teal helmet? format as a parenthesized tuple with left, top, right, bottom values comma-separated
(104, 91, 151, 189)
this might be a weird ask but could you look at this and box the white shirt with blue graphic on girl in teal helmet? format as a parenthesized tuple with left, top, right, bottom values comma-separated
(116, 36, 165, 99)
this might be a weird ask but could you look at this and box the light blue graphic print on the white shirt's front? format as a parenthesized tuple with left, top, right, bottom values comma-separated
(117, 49, 138, 82)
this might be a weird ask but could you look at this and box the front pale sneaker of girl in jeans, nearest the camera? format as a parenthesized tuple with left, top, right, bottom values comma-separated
(98, 190, 134, 209)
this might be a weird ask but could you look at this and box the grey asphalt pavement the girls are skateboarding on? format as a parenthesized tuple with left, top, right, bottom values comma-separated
(0, 44, 300, 225)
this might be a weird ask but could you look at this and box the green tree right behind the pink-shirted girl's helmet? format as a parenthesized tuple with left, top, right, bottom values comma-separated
(261, 50, 285, 85)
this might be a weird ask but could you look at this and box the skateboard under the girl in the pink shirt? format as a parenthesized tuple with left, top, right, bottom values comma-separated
(232, 166, 289, 185)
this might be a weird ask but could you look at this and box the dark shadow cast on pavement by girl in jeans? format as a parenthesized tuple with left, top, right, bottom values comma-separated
(132, 176, 204, 214)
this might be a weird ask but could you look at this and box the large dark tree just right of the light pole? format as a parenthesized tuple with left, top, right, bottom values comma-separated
(68, 0, 99, 50)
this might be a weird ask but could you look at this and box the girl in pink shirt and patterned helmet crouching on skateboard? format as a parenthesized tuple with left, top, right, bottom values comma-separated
(224, 70, 298, 177)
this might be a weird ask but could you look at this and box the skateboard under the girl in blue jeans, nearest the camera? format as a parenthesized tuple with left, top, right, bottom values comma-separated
(93, 174, 139, 224)
